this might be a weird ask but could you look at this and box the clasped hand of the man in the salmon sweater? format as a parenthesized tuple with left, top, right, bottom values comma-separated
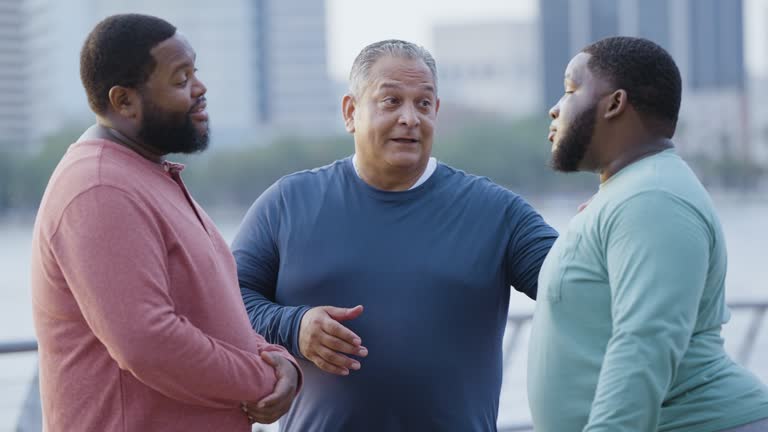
(242, 352, 299, 424)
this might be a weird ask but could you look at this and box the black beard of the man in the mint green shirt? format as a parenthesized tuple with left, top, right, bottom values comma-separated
(551, 104, 597, 172)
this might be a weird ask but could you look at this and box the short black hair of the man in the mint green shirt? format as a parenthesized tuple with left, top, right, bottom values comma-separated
(582, 36, 682, 138)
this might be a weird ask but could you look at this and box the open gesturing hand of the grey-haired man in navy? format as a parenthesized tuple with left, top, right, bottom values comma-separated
(299, 305, 368, 375)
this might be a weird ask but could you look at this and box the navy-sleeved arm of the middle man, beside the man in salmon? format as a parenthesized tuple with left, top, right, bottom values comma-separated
(232, 183, 310, 358)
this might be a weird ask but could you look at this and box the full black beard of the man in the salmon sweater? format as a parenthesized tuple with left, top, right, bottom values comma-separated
(138, 96, 209, 154)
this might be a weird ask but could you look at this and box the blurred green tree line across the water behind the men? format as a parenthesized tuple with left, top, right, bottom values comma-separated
(0, 118, 766, 212)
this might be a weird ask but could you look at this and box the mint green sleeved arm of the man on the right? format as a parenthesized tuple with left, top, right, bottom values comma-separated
(584, 192, 710, 432)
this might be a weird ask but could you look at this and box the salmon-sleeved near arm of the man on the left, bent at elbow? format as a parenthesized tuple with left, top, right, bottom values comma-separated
(50, 186, 277, 408)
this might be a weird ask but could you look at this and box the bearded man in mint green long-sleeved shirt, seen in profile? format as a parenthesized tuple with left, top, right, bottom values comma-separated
(528, 37, 768, 432)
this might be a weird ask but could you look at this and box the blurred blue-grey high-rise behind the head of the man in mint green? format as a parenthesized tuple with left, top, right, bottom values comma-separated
(539, 0, 753, 160)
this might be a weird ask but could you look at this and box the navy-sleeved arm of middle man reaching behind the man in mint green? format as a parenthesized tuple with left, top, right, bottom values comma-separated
(506, 197, 557, 300)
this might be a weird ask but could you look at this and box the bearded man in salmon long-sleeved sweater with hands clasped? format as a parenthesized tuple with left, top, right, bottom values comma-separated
(32, 14, 301, 432)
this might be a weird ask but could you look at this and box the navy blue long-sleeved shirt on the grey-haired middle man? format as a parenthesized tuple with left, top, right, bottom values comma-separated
(232, 158, 557, 432)
